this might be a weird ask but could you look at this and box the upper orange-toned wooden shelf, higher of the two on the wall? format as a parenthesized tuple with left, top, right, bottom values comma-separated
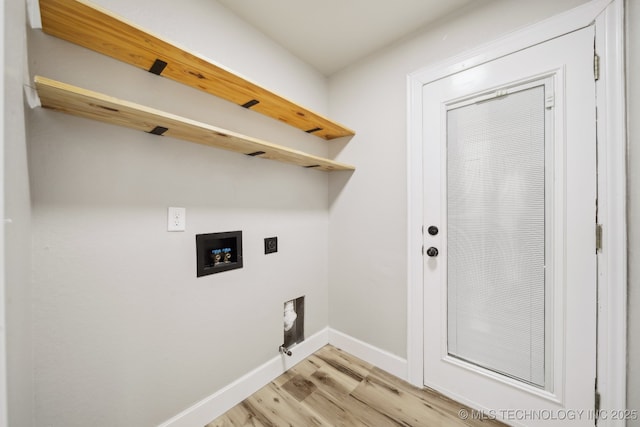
(40, 0, 355, 140)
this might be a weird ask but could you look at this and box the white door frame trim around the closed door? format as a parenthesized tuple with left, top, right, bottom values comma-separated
(407, 0, 627, 426)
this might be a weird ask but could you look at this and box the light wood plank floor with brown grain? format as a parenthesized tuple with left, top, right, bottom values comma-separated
(206, 345, 504, 427)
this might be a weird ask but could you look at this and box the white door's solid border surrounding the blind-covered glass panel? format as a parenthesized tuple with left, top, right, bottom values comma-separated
(423, 27, 596, 425)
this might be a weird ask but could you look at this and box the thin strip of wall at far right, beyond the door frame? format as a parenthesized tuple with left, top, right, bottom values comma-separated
(625, 0, 640, 427)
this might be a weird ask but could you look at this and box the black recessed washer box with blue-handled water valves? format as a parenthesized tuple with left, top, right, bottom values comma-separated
(196, 231, 242, 277)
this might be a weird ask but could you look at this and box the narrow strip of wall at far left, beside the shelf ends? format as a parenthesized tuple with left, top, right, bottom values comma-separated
(3, 0, 33, 426)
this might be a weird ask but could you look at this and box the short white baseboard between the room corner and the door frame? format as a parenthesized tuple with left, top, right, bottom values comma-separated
(329, 329, 408, 381)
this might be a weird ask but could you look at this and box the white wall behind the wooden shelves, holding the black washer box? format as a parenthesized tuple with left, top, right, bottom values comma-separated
(27, 0, 328, 427)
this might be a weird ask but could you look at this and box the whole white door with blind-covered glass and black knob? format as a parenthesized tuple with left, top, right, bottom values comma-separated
(423, 27, 596, 426)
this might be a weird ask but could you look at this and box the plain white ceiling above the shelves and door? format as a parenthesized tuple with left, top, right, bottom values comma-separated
(218, 0, 478, 76)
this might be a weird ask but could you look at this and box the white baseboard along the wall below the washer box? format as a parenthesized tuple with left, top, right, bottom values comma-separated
(158, 328, 329, 427)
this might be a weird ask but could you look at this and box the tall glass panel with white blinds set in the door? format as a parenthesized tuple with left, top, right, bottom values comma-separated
(447, 86, 545, 387)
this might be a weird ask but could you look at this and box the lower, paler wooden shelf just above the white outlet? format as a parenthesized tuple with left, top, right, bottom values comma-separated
(35, 76, 355, 171)
